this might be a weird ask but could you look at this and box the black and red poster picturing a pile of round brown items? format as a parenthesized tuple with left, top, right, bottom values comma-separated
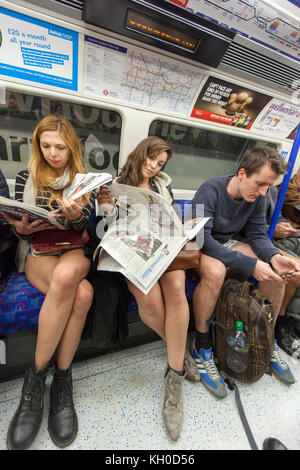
(191, 77, 271, 129)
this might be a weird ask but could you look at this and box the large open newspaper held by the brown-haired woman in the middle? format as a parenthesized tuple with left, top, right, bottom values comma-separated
(95, 183, 208, 294)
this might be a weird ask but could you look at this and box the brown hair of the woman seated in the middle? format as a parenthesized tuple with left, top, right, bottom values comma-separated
(117, 136, 172, 186)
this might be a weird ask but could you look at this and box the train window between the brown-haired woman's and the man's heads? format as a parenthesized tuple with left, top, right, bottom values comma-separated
(149, 120, 276, 189)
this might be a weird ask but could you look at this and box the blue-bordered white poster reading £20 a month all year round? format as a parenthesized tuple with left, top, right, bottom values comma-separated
(0, 7, 78, 90)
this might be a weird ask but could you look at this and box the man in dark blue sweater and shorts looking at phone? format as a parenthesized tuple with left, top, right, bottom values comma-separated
(191, 147, 300, 392)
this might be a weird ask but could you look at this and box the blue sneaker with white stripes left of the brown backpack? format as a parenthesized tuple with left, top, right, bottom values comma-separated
(191, 339, 227, 398)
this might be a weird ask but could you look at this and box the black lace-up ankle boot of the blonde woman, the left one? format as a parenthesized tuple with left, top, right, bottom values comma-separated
(7, 364, 50, 450)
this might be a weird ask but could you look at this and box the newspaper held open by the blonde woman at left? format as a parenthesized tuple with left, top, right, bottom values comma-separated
(0, 173, 112, 230)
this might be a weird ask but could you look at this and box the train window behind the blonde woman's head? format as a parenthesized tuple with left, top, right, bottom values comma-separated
(0, 90, 122, 179)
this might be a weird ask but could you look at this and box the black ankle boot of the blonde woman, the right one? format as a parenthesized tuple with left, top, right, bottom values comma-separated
(48, 369, 78, 447)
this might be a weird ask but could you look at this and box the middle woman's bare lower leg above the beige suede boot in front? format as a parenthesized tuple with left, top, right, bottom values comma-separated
(160, 271, 189, 370)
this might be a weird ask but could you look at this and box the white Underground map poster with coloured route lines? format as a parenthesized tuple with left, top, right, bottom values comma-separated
(84, 35, 204, 116)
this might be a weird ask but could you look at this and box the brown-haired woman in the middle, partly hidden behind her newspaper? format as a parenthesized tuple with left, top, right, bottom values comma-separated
(98, 136, 199, 440)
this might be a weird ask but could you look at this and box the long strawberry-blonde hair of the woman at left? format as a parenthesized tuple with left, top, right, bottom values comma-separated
(28, 114, 89, 206)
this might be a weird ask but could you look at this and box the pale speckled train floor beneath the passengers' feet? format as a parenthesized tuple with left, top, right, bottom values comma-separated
(0, 341, 300, 450)
